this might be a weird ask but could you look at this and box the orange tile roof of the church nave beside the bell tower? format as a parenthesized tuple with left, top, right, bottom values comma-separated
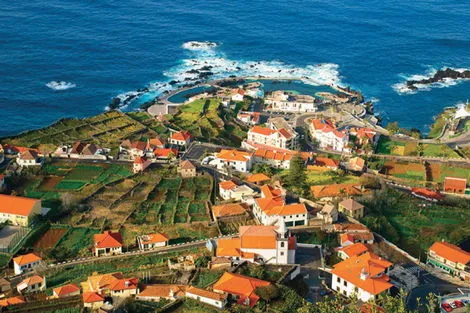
(240, 225, 277, 249)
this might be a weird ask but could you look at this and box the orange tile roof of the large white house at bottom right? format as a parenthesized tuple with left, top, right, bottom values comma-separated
(331, 252, 393, 295)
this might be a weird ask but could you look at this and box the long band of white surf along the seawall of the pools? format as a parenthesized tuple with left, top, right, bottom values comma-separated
(113, 41, 341, 108)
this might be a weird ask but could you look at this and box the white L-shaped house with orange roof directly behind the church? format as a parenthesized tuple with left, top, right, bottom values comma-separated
(253, 185, 308, 227)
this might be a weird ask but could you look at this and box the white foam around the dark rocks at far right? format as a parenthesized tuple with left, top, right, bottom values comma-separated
(392, 68, 468, 94)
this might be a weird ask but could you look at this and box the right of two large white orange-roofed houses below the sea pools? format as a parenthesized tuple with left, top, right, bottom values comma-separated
(309, 119, 349, 152)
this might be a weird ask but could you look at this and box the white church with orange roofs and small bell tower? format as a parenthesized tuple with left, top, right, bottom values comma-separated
(216, 225, 297, 264)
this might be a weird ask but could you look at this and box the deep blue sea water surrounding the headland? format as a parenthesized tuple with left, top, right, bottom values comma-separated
(0, 0, 470, 136)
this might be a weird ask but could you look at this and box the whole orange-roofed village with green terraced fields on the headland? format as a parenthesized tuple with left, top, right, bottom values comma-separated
(0, 78, 470, 313)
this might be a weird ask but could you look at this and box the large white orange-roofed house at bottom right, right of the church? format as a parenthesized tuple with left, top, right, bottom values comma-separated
(331, 252, 393, 302)
